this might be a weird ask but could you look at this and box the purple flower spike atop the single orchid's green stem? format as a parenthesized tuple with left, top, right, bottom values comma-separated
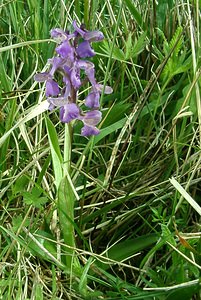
(35, 21, 112, 136)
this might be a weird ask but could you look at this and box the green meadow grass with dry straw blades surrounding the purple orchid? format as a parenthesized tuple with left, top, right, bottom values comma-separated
(0, 0, 201, 300)
